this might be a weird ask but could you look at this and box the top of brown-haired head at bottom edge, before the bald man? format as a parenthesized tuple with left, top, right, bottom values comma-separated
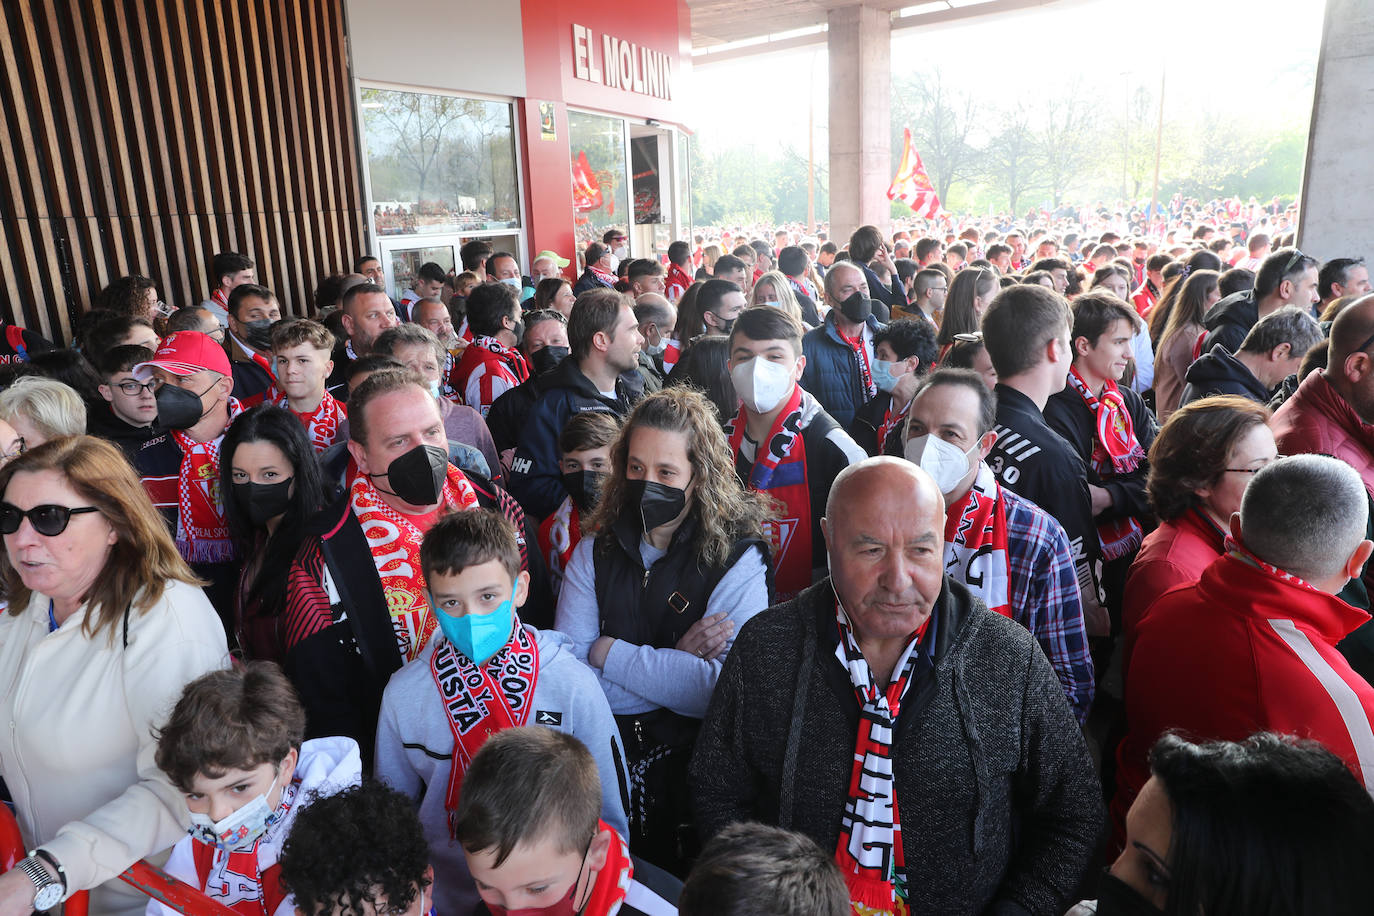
(677, 823, 849, 916)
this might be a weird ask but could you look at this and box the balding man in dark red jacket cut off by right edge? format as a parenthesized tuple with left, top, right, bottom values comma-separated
(1270, 295, 1374, 494)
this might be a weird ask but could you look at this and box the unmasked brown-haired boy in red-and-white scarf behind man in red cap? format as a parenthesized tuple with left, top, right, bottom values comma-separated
(272, 319, 348, 455)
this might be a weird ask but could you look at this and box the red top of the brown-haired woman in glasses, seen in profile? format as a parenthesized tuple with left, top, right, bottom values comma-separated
(1121, 508, 1226, 654)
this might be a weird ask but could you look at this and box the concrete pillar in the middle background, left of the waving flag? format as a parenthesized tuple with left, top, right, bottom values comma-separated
(826, 4, 892, 247)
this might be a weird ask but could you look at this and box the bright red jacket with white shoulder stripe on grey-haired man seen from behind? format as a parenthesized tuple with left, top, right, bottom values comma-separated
(1112, 553, 1374, 843)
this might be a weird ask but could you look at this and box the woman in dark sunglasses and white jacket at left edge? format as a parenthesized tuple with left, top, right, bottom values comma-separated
(0, 435, 229, 916)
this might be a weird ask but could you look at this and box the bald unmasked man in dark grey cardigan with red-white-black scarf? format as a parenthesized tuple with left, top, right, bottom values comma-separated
(690, 457, 1102, 915)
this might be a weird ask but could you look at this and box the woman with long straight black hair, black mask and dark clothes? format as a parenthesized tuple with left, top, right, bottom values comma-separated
(220, 404, 330, 663)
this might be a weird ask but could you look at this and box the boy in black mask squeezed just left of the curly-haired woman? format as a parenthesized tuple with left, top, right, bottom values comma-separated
(539, 411, 620, 597)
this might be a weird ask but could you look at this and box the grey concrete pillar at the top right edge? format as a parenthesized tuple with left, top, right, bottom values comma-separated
(1298, 0, 1374, 261)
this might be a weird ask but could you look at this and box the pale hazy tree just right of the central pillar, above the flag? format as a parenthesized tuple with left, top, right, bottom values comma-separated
(892, 71, 978, 201)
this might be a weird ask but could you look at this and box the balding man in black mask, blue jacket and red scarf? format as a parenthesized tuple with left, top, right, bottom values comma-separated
(801, 261, 883, 427)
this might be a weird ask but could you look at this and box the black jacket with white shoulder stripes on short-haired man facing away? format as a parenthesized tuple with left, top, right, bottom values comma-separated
(988, 385, 1102, 602)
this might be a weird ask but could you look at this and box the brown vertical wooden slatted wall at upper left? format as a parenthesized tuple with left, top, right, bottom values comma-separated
(0, 0, 365, 341)
